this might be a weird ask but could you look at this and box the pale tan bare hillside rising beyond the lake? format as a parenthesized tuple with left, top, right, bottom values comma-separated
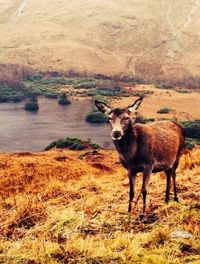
(0, 0, 200, 78)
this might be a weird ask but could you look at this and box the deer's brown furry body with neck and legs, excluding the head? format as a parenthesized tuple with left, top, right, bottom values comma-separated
(114, 121, 185, 212)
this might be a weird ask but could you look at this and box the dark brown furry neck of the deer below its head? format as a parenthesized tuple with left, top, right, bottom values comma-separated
(114, 122, 137, 158)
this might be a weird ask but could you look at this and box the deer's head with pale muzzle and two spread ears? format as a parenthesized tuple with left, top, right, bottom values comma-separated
(95, 97, 143, 140)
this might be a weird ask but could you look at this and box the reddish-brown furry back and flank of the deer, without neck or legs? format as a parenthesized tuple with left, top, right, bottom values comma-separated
(133, 121, 184, 170)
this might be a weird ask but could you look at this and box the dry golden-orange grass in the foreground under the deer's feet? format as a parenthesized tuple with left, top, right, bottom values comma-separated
(0, 148, 200, 264)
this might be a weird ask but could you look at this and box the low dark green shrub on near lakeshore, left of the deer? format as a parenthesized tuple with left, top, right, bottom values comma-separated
(45, 137, 100, 150)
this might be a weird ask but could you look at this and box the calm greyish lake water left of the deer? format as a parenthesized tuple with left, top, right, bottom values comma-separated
(0, 98, 113, 151)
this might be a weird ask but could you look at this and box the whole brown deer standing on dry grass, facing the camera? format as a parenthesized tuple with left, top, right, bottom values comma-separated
(95, 97, 185, 214)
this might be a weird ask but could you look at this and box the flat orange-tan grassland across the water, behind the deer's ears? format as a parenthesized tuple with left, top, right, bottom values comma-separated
(112, 84, 200, 120)
